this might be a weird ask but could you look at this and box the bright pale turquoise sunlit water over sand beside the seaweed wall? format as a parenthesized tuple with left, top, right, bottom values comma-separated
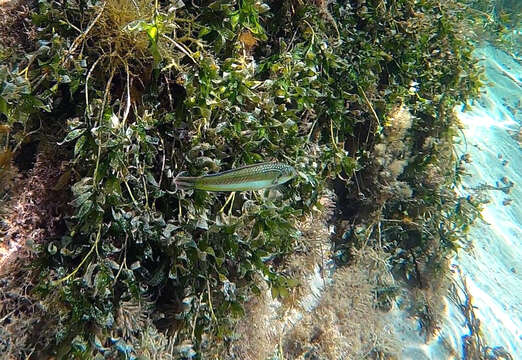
(391, 46, 522, 360)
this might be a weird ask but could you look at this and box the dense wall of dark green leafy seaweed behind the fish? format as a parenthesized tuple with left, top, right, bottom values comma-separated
(0, 0, 502, 359)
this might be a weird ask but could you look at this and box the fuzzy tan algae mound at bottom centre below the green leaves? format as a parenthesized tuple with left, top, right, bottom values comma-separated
(230, 200, 397, 360)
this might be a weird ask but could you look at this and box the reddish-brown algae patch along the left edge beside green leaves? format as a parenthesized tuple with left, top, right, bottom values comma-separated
(0, 145, 70, 358)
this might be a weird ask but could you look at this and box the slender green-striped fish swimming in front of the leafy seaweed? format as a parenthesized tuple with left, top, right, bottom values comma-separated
(174, 162, 296, 191)
